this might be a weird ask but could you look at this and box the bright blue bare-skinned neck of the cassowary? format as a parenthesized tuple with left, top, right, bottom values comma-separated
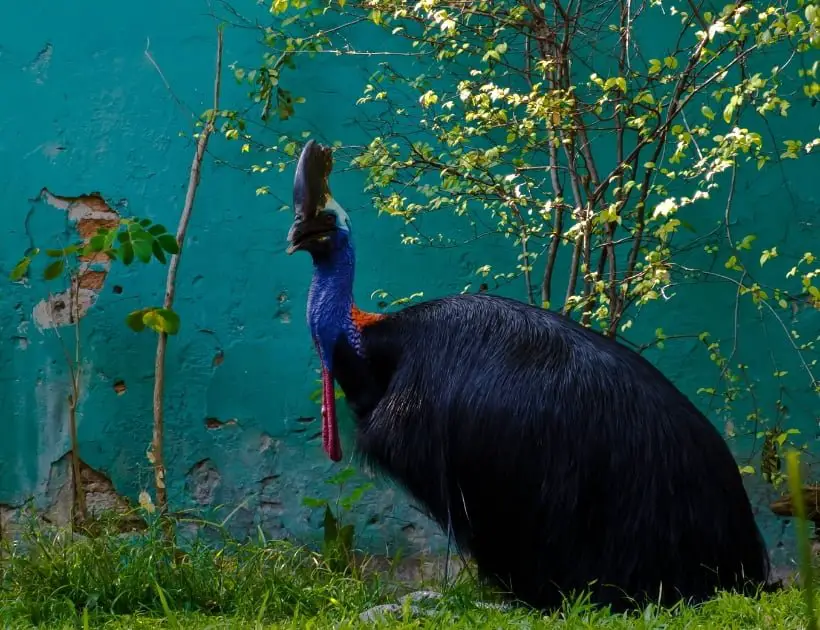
(307, 242, 361, 372)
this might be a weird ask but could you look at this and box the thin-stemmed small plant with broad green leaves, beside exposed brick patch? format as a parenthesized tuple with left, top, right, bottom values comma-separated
(10, 218, 179, 524)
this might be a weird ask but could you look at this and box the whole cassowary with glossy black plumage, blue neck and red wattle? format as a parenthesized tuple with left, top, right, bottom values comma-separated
(287, 140, 769, 610)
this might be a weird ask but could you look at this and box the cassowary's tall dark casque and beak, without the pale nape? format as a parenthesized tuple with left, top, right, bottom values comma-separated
(286, 140, 336, 254)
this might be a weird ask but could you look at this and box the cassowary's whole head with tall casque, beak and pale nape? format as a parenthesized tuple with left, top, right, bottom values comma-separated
(287, 140, 350, 260)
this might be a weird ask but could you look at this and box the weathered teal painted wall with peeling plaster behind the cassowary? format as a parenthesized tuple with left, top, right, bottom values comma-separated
(0, 0, 820, 564)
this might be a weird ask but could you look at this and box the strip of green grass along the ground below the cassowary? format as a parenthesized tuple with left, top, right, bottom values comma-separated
(0, 512, 807, 630)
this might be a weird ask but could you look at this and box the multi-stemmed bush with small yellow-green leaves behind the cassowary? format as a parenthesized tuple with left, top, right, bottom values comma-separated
(219, 0, 820, 484)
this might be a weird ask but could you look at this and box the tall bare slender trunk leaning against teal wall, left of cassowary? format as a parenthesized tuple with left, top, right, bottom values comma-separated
(151, 27, 222, 514)
